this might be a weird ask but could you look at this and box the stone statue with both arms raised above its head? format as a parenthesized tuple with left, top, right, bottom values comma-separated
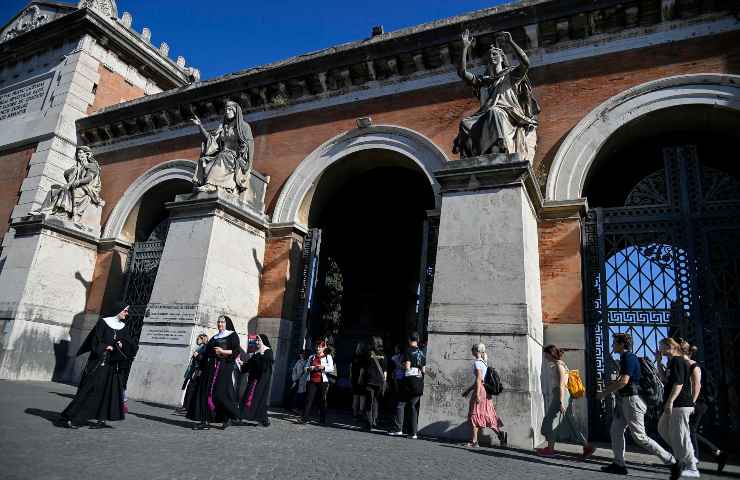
(452, 30, 540, 161)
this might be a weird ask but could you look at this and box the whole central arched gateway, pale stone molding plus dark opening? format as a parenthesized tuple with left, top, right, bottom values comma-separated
(273, 125, 447, 390)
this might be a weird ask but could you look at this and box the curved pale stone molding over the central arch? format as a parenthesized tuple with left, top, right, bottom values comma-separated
(273, 125, 448, 225)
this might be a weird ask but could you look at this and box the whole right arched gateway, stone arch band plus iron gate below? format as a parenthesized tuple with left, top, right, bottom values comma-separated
(547, 74, 740, 437)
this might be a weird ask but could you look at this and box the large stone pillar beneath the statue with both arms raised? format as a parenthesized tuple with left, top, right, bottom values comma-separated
(420, 155, 544, 449)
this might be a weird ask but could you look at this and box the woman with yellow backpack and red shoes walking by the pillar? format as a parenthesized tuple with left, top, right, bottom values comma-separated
(537, 345, 596, 459)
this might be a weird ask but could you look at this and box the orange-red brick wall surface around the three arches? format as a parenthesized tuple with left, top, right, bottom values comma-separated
(89, 32, 740, 323)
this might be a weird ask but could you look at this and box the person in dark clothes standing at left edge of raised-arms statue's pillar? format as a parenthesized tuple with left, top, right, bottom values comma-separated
(389, 332, 426, 439)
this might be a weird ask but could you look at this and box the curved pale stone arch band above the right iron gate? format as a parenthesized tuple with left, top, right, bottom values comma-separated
(545, 74, 740, 201)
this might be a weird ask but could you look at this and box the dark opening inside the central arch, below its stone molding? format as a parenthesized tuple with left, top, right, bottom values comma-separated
(307, 149, 435, 400)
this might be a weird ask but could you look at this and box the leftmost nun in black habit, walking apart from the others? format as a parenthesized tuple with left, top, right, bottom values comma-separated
(61, 303, 137, 428)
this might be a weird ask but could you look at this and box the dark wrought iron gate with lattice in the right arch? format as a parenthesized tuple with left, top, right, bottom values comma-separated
(583, 146, 740, 439)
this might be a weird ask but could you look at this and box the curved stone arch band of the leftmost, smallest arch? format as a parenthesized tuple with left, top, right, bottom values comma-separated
(101, 160, 195, 240)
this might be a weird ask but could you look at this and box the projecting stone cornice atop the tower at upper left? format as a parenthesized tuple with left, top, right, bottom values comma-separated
(0, 9, 188, 90)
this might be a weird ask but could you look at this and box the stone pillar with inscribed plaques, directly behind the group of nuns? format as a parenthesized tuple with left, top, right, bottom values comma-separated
(128, 191, 267, 405)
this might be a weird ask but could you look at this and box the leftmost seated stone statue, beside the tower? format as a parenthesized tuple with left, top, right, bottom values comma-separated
(29, 146, 105, 222)
